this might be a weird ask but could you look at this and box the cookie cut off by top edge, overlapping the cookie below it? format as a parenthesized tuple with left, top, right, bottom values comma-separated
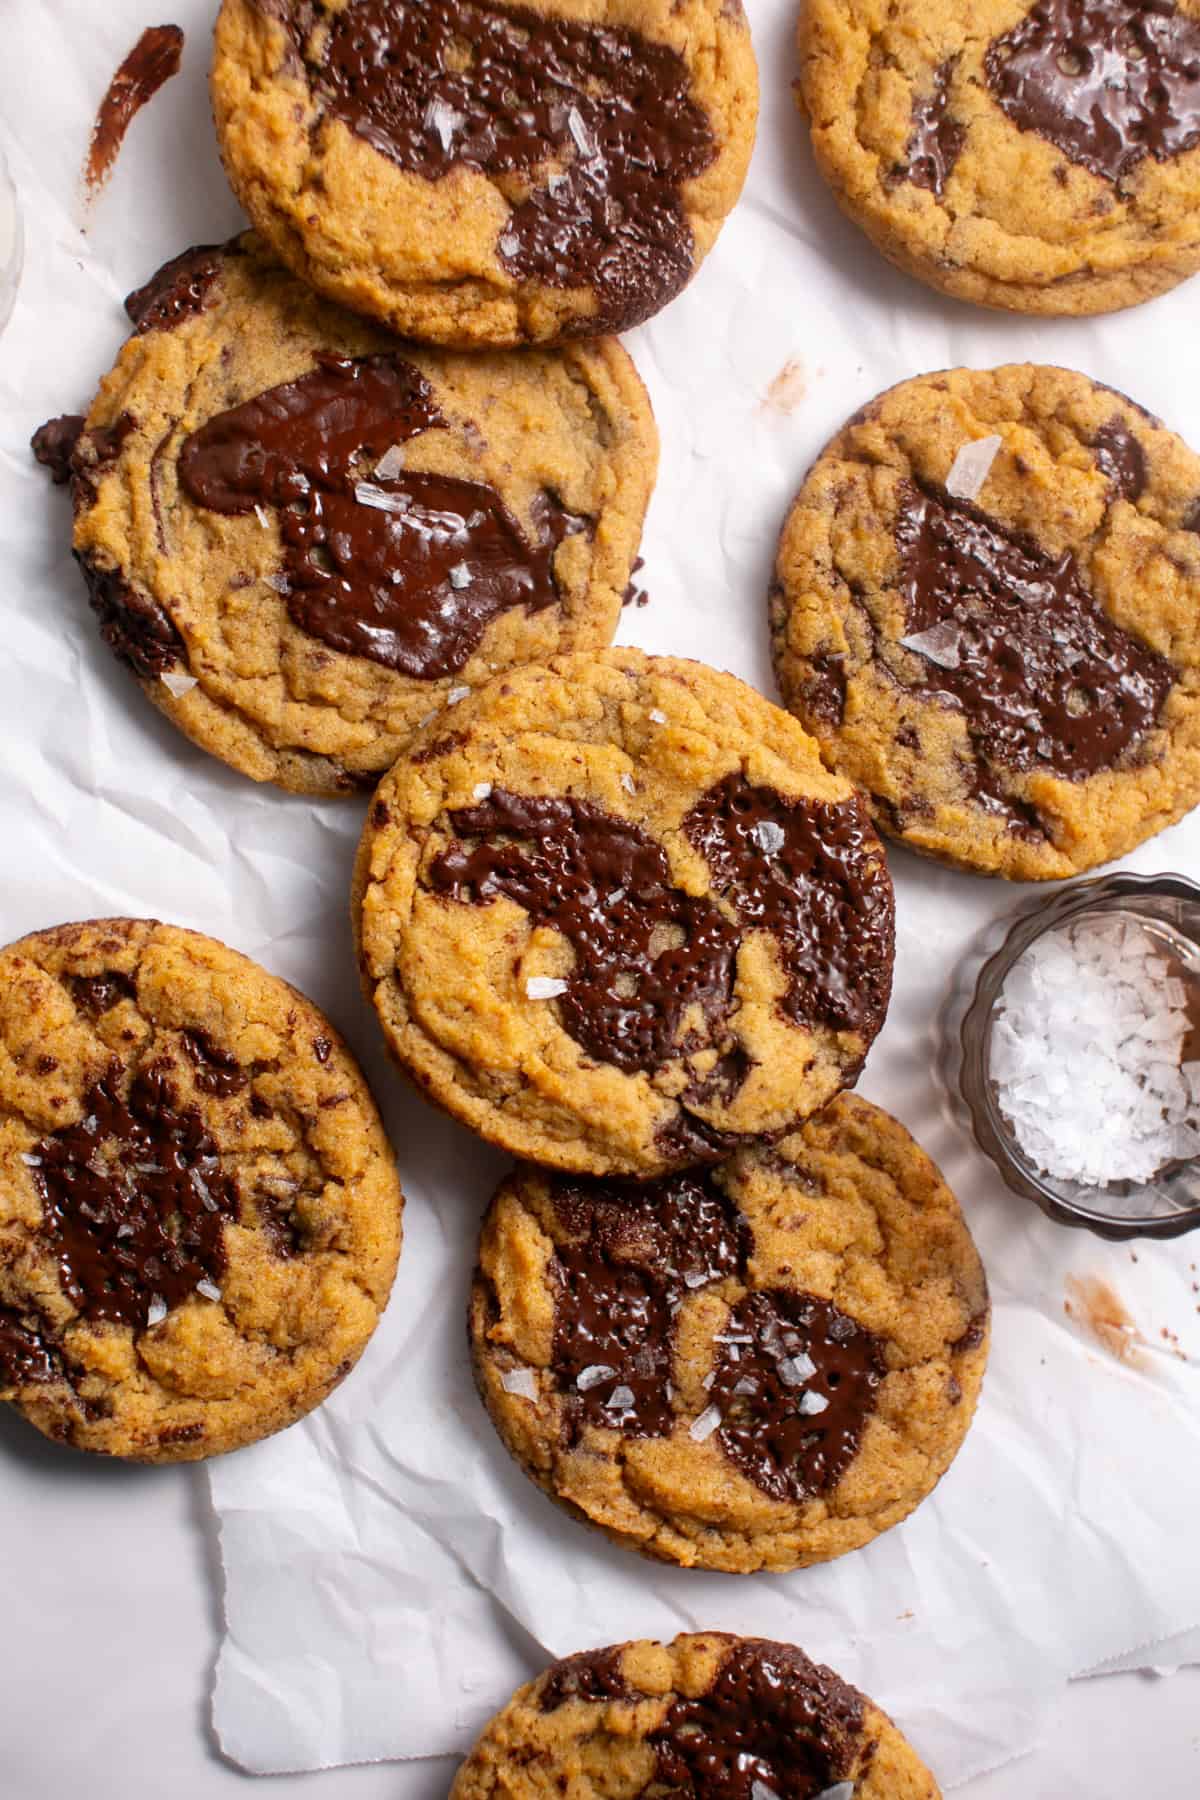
(212, 0, 757, 347)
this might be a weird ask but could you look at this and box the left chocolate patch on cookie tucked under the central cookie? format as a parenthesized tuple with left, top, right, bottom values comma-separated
(551, 1174, 752, 1444)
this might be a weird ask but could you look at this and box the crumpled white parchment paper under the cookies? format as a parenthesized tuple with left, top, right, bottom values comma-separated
(0, 0, 1200, 1795)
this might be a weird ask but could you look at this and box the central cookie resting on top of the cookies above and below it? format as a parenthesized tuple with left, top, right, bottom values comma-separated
(353, 650, 894, 1177)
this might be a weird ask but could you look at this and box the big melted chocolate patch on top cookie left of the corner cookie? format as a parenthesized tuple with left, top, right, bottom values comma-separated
(282, 0, 716, 333)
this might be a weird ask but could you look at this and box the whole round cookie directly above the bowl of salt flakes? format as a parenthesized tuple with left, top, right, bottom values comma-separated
(770, 365, 1200, 880)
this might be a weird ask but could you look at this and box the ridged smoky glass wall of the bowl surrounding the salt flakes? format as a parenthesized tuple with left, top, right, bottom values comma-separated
(943, 875, 1200, 1240)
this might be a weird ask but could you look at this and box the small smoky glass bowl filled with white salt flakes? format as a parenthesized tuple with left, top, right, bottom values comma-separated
(959, 875, 1200, 1238)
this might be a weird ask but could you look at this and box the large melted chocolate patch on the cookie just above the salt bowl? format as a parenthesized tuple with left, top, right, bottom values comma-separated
(896, 488, 1175, 794)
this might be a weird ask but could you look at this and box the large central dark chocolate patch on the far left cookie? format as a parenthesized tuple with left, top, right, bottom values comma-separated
(34, 1062, 239, 1330)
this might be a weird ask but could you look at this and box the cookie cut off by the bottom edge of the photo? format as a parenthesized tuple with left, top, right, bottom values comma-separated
(450, 1631, 941, 1800)
